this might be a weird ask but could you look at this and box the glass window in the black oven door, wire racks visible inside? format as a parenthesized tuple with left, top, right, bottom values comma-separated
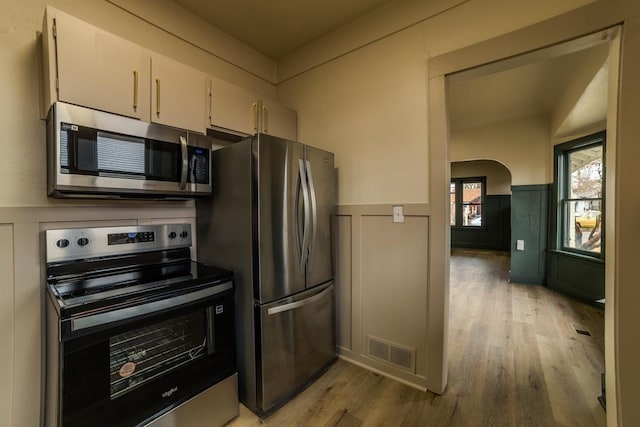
(109, 310, 213, 399)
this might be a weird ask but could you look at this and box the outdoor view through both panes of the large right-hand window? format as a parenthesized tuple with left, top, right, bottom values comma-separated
(560, 142, 604, 254)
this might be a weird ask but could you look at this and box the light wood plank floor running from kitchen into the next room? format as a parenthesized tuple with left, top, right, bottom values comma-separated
(230, 249, 606, 427)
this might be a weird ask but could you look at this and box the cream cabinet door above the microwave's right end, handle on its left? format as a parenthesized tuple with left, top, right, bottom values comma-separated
(151, 54, 207, 133)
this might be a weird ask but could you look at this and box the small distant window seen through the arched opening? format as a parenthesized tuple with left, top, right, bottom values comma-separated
(449, 177, 486, 227)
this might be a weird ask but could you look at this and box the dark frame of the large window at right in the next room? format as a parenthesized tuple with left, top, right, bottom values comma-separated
(553, 131, 606, 260)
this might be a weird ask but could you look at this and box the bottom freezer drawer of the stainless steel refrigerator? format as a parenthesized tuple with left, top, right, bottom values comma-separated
(256, 282, 336, 413)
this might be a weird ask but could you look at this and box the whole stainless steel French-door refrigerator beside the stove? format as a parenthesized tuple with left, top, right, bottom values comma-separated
(196, 134, 336, 416)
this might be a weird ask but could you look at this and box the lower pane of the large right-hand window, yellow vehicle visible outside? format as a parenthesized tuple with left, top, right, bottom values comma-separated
(564, 199, 603, 253)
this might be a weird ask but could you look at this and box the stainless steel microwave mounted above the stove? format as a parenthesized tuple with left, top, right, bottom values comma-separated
(47, 102, 212, 199)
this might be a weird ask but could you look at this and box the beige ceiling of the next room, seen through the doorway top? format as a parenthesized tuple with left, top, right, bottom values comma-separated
(449, 43, 608, 134)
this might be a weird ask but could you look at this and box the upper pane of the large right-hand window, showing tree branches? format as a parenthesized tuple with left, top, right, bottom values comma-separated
(568, 145, 604, 199)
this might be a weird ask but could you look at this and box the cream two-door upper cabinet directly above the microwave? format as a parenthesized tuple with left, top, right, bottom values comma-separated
(42, 6, 206, 133)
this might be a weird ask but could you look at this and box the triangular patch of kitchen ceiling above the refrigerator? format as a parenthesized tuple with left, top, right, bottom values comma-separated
(174, 0, 390, 60)
